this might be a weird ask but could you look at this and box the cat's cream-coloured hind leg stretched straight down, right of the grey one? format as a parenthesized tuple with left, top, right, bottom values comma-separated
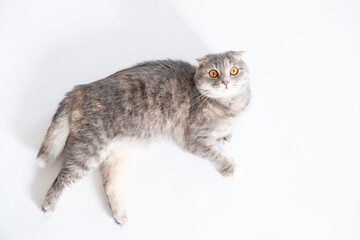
(101, 152, 129, 225)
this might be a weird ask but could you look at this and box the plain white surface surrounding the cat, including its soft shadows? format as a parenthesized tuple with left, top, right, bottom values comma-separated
(0, 0, 360, 240)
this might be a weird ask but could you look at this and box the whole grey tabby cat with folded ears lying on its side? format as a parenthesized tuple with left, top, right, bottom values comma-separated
(37, 51, 250, 224)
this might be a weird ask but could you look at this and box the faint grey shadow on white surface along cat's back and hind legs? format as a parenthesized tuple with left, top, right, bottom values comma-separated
(19, 0, 210, 216)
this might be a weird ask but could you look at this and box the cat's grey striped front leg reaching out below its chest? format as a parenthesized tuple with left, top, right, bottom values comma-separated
(185, 138, 236, 176)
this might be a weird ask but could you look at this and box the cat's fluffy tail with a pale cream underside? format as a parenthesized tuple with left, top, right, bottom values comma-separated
(37, 94, 72, 168)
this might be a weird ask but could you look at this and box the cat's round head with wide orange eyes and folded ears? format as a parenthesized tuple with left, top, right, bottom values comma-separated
(195, 51, 248, 99)
